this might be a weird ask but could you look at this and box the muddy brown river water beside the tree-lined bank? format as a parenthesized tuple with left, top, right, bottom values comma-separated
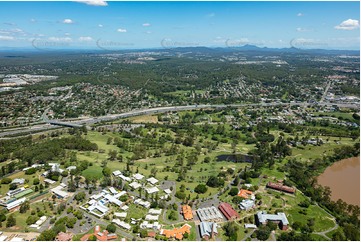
(318, 157, 360, 206)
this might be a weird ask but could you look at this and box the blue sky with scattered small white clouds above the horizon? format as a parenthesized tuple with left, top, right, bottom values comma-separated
(0, 0, 360, 50)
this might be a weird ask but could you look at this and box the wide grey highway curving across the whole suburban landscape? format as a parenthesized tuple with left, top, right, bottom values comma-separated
(0, 102, 360, 137)
